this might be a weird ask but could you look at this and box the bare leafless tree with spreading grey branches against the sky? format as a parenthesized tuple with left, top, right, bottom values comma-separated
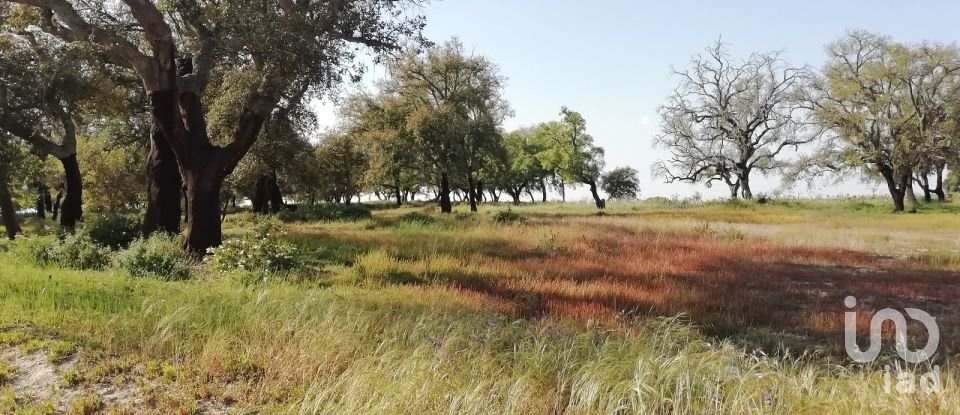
(654, 41, 820, 199)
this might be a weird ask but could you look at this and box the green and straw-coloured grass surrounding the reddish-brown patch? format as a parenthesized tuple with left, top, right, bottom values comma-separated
(0, 200, 960, 414)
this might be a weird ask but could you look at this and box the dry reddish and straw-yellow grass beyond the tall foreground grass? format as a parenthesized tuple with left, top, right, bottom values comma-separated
(293, 201, 960, 355)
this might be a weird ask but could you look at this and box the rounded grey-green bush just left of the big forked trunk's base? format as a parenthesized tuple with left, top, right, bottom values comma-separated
(114, 233, 194, 281)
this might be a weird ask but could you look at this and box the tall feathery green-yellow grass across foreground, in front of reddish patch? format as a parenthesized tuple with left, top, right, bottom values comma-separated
(0, 264, 960, 414)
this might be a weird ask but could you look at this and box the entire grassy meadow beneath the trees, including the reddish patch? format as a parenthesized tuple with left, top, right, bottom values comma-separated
(0, 199, 960, 414)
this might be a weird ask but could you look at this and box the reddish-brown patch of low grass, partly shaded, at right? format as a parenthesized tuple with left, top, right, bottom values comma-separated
(434, 236, 960, 356)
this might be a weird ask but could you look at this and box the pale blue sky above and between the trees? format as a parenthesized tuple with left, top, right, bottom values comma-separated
(318, 0, 960, 199)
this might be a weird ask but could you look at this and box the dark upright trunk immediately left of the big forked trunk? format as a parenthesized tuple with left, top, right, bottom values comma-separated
(143, 121, 183, 235)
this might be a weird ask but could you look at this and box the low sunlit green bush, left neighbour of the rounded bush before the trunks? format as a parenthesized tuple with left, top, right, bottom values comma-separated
(36, 232, 111, 270)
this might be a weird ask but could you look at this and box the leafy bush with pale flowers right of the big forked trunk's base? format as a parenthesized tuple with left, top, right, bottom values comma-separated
(205, 218, 302, 279)
